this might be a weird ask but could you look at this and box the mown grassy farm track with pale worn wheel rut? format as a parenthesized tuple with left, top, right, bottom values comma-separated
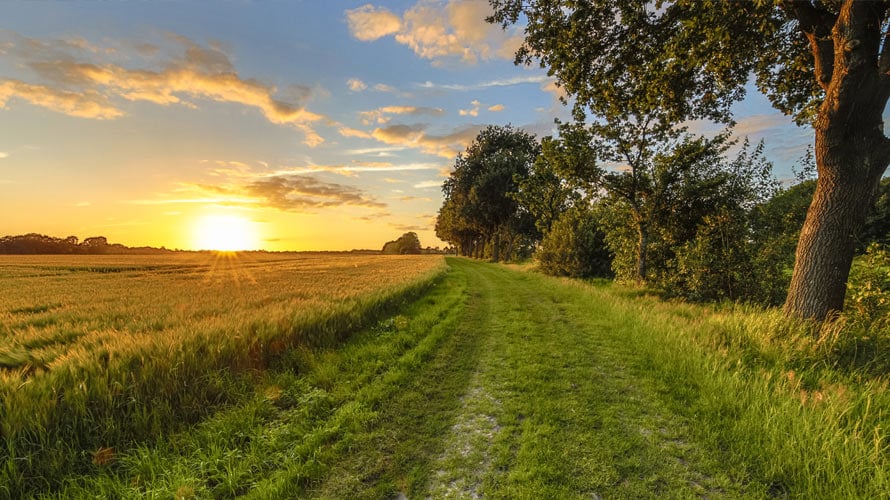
(312, 259, 744, 498)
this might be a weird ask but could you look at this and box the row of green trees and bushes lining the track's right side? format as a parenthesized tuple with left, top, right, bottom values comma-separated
(436, 123, 890, 305)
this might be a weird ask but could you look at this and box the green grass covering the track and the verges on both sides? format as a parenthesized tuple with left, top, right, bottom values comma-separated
(0, 259, 890, 499)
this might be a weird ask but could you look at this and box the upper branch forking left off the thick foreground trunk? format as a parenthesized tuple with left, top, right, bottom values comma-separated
(781, 0, 837, 91)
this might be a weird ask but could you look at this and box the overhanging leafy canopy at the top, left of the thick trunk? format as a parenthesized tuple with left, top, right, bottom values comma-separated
(489, 0, 816, 123)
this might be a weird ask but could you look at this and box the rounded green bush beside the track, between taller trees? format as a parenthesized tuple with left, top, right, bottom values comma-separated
(535, 205, 612, 278)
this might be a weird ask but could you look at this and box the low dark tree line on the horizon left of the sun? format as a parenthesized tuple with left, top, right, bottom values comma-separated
(0, 233, 172, 255)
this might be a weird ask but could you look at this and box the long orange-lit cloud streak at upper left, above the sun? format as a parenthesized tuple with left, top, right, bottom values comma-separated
(0, 35, 323, 146)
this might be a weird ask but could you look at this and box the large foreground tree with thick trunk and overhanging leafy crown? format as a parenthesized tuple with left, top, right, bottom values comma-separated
(489, 0, 890, 320)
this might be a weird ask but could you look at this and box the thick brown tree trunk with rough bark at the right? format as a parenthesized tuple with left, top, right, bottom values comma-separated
(785, 0, 890, 321)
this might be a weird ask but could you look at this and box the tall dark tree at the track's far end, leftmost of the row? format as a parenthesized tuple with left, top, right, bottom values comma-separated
(436, 125, 540, 261)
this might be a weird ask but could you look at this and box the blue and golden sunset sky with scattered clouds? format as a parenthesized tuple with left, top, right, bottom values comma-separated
(0, 0, 812, 251)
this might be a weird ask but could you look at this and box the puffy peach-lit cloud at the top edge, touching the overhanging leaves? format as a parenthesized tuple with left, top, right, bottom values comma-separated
(346, 0, 522, 64)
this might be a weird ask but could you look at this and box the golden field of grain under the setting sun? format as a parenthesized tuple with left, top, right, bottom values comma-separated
(0, 253, 445, 497)
